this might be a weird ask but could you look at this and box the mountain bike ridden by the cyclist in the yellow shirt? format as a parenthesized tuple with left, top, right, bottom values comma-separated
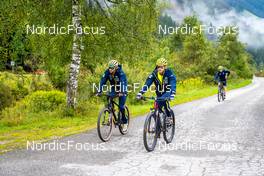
(142, 97, 175, 152)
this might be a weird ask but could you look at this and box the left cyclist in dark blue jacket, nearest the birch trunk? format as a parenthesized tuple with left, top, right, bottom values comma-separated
(97, 60, 127, 124)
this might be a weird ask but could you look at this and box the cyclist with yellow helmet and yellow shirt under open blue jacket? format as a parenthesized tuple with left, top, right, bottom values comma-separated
(137, 58, 176, 117)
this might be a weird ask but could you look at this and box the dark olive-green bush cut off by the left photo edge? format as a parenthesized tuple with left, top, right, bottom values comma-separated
(0, 82, 13, 111)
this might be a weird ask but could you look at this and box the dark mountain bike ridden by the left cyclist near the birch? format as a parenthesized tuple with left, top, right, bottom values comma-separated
(97, 94, 130, 142)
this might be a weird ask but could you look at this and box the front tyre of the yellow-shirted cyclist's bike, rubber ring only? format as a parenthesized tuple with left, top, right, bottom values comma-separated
(143, 112, 157, 152)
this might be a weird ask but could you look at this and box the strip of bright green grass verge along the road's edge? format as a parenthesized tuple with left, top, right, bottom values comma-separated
(0, 80, 251, 153)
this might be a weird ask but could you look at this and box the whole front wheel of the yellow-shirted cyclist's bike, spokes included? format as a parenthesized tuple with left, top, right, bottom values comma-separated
(143, 112, 157, 152)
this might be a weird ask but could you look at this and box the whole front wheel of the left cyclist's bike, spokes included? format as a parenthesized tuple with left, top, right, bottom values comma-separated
(97, 108, 113, 142)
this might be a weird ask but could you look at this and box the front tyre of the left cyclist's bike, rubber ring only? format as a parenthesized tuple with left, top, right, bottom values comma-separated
(97, 108, 113, 142)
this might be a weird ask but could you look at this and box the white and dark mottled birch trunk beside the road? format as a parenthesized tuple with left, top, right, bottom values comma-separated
(67, 0, 82, 108)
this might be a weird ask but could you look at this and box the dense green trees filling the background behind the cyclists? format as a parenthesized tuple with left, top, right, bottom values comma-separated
(0, 0, 255, 108)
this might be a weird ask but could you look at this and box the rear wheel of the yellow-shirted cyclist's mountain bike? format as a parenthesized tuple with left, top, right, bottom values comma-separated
(163, 110, 175, 144)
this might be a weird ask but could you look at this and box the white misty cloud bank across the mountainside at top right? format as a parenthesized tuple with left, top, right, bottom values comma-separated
(166, 0, 264, 47)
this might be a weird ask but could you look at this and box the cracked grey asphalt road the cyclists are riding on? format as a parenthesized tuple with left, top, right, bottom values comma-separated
(0, 78, 264, 176)
